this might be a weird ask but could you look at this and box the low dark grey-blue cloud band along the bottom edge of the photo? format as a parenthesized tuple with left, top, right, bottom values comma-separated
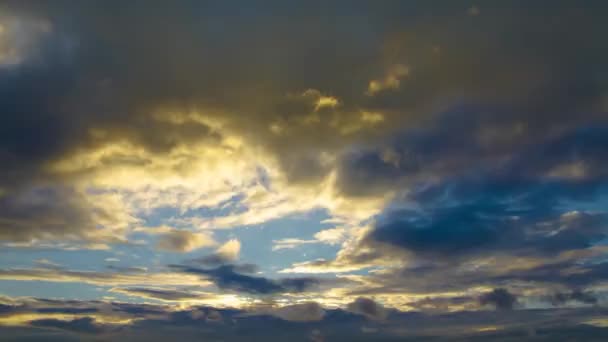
(0, 298, 608, 341)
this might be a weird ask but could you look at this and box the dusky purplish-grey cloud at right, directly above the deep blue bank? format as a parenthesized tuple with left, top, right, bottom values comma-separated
(339, 113, 608, 196)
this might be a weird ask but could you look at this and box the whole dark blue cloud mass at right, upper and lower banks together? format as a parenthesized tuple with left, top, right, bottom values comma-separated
(343, 113, 608, 266)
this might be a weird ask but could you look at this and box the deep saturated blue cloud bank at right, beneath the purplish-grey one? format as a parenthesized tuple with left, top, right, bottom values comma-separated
(368, 184, 606, 257)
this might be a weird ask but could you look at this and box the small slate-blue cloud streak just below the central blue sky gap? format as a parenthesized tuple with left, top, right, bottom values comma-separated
(170, 265, 320, 295)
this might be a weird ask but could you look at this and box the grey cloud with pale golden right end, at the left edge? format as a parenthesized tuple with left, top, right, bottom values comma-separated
(0, 186, 137, 244)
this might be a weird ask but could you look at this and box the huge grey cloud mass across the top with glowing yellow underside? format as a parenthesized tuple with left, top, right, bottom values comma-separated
(0, 3, 606, 248)
